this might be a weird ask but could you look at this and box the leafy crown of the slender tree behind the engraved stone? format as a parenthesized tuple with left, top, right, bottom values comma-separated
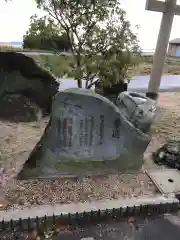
(33, 0, 139, 87)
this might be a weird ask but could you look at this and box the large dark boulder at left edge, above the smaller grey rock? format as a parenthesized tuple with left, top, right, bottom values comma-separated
(0, 52, 59, 113)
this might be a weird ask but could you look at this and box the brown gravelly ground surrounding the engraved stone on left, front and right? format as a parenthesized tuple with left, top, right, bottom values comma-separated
(0, 93, 180, 207)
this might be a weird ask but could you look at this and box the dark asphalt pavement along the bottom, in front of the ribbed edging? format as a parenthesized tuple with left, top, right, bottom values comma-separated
(0, 214, 180, 240)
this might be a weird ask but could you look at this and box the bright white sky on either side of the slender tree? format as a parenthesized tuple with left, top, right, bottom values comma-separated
(0, 0, 180, 50)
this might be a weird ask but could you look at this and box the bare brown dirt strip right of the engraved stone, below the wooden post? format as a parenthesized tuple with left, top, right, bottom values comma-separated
(143, 93, 180, 169)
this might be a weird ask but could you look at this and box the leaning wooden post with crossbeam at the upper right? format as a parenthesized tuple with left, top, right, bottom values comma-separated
(146, 0, 180, 99)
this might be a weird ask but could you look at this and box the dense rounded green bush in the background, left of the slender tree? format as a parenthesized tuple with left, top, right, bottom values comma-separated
(23, 15, 70, 51)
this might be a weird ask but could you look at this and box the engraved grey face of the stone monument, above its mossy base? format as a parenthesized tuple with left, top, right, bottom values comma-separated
(40, 89, 150, 161)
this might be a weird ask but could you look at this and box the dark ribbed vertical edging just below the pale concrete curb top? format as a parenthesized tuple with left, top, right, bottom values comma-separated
(0, 202, 179, 232)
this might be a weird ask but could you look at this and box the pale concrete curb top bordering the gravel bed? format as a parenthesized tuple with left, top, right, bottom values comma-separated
(0, 196, 179, 222)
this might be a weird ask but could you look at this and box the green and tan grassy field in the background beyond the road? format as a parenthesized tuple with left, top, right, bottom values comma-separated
(0, 46, 180, 78)
